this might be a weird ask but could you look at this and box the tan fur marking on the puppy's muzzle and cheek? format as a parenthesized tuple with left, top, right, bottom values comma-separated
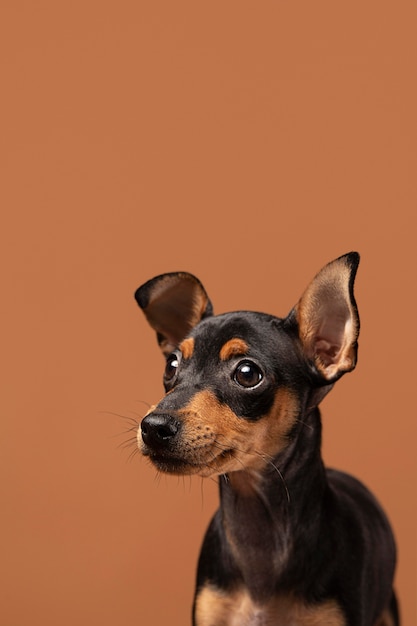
(173, 388, 298, 476)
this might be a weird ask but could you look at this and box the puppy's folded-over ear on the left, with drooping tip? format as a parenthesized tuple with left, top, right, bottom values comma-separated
(135, 272, 213, 355)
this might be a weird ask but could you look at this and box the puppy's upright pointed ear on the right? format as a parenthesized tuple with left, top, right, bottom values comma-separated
(292, 252, 359, 383)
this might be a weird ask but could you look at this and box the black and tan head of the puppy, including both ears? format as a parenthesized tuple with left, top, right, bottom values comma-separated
(135, 253, 359, 476)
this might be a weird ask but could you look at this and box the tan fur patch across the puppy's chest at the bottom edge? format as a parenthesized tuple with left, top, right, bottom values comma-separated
(196, 586, 346, 626)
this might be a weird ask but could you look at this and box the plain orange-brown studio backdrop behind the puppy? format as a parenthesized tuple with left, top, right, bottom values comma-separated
(0, 0, 417, 626)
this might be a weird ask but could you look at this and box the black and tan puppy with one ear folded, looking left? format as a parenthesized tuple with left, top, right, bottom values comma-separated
(135, 253, 399, 626)
